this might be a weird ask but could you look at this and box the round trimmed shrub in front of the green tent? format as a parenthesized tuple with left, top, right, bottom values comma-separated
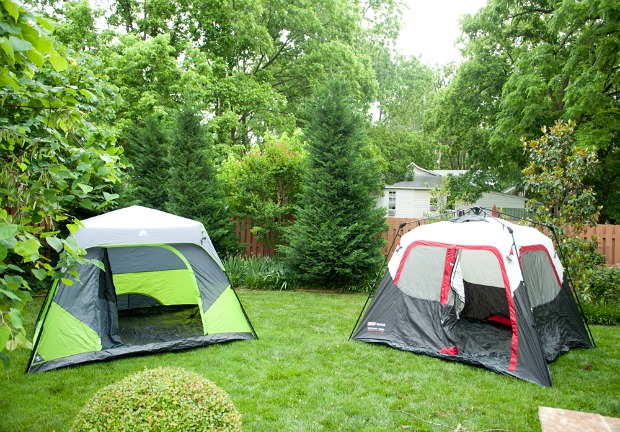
(71, 367, 241, 432)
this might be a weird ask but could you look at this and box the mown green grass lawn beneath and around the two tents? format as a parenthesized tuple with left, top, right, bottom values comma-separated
(0, 291, 620, 431)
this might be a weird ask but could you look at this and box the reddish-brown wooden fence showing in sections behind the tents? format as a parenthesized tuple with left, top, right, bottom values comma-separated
(235, 218, 620, 265)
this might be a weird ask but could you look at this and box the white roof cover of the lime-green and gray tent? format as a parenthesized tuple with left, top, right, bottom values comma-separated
(73, 206, 221, 264)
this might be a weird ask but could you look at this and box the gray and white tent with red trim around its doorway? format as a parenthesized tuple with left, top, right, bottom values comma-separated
(352, 212, 593, 386)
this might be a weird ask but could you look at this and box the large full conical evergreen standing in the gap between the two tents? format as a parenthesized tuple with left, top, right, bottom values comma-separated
(282, 80, 385, 286)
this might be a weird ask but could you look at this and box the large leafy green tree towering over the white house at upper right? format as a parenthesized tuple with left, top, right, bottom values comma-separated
(462, 0, 620, 216)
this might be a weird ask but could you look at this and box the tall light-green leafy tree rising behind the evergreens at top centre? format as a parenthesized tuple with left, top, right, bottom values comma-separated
(98, 0, 398, 150)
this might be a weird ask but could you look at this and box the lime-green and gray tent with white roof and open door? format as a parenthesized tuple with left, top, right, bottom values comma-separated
(27, 206, 257, 372)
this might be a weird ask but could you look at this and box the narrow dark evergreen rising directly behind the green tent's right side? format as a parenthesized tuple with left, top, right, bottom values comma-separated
(166, 107, 238, 254)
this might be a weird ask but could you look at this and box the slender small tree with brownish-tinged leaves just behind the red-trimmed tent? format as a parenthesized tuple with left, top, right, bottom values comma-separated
(522, 121, 600, 294)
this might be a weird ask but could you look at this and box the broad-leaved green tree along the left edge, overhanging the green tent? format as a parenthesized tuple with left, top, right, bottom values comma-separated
(0, 0, 124, 365)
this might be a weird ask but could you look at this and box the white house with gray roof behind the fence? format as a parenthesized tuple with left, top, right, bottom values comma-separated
(377, 164, 527, 219)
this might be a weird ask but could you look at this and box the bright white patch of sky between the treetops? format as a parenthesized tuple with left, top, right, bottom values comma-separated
(396, 0, 487, 66)
